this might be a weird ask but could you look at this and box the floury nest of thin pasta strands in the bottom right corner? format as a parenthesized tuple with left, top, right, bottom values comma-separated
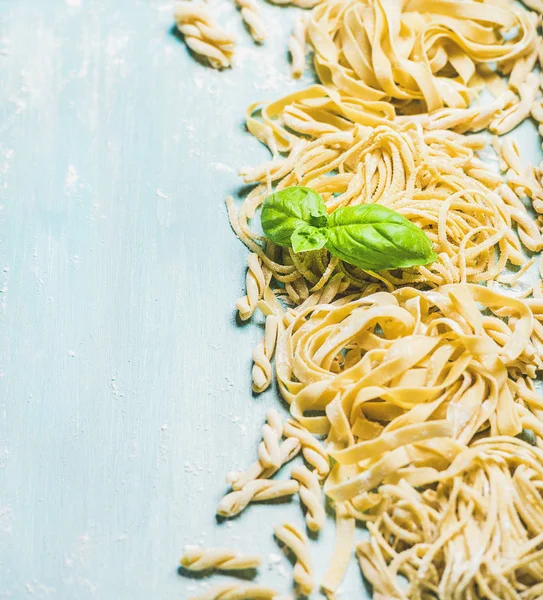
(357, 437, 543, 600)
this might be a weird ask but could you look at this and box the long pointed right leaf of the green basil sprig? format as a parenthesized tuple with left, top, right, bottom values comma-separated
(326, 204, 437, 271)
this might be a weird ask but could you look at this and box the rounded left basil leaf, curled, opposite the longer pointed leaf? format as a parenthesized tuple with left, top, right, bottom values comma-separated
(260, 187, 328, 248)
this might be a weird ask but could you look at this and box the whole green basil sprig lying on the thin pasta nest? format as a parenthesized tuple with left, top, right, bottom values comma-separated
(260, 187, 437, 271)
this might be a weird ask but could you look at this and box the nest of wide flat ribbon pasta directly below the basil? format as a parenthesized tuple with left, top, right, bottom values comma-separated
(276, 285, 543, 502)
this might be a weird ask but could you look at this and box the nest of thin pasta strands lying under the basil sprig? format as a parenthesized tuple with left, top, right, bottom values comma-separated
(229, 123, 543, 314)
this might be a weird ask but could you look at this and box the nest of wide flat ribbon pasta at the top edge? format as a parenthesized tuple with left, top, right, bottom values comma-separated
(309, 0, 539, 118)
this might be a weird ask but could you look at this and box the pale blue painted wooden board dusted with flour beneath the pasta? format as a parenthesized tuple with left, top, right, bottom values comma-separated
(0, 0, 539, 600)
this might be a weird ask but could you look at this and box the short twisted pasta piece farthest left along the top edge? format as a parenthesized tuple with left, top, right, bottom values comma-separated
(174, 1, 236, 69)
